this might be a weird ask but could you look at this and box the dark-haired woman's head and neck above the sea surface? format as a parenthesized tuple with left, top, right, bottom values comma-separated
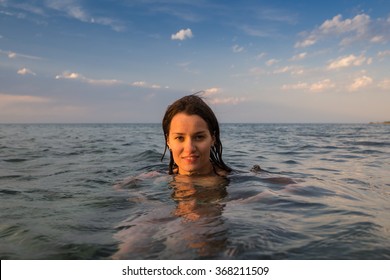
(162, 95, 232, 176)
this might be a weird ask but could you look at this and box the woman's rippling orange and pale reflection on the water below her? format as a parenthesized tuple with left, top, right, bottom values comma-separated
(113, 175, 229, 259)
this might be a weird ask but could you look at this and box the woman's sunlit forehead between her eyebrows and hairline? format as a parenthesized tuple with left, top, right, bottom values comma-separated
(170, 113, 208, 133)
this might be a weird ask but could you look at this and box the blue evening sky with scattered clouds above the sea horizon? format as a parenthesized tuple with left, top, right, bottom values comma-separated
(0, 0, 390, 123)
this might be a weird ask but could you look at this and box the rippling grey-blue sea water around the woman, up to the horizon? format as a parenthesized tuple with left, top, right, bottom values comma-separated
(0, 124, 390, 259)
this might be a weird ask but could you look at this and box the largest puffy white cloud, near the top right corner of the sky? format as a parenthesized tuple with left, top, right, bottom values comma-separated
(295, 13, 389, 48)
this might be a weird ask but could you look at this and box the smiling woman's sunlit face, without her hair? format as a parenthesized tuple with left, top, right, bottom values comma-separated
(167, 113, 214, 175)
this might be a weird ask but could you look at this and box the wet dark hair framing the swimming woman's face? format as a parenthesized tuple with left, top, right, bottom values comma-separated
(161, 93, 232, 174)
